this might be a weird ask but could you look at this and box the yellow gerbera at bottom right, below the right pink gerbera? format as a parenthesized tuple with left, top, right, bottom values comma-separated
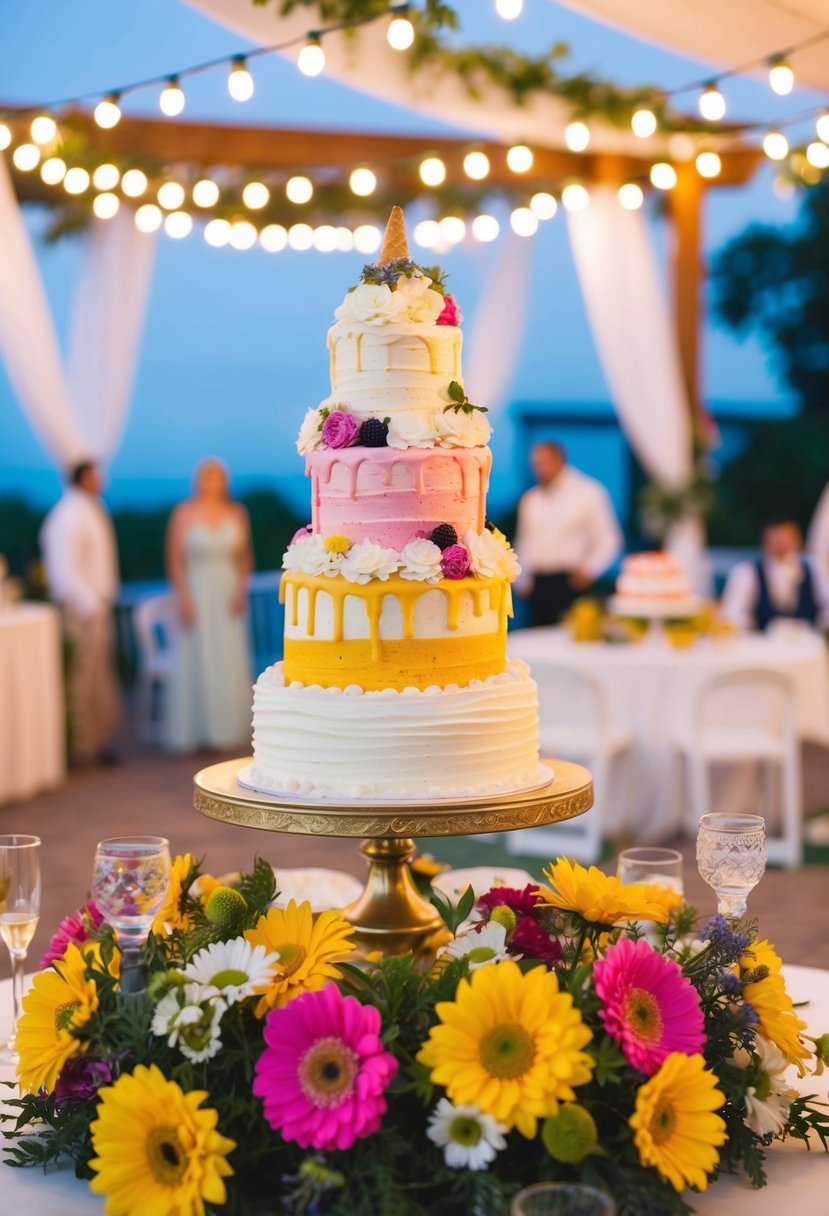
(630, 1052, 726, 1190)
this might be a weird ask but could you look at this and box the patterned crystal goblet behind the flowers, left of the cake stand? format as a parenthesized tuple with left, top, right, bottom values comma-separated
(92, 835, 170, 992)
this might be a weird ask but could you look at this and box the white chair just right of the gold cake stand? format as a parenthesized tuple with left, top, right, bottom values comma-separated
(506, 662, 635, 862)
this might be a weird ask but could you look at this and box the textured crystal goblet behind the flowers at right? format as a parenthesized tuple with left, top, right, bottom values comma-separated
(697, 814, 766, 921)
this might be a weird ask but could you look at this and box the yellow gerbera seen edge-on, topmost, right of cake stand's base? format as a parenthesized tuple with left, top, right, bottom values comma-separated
(538, 857, 667, 924)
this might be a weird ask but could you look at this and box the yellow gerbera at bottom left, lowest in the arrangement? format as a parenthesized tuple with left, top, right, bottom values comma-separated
(89, 1064, 236, 1216)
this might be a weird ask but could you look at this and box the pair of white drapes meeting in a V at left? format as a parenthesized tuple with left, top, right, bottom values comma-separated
(0, 156, 156, 467)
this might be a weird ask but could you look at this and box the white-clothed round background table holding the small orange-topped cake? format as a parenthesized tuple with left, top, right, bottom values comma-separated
(508, 627, 829, 841)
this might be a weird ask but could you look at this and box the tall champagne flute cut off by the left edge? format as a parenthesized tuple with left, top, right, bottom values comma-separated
(0, 835, 40, 1062)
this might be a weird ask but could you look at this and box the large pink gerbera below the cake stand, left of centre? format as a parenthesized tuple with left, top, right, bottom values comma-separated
(253, 984, 397, 1152)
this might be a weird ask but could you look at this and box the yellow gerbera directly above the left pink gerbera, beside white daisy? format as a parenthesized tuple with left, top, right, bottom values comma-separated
(244, 900, 354, 1018)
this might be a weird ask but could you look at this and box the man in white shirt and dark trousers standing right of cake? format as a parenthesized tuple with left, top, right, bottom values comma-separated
(515, 443, 624, 625)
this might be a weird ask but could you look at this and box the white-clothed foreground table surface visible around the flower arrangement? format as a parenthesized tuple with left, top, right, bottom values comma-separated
(0, 967, 829, 1216)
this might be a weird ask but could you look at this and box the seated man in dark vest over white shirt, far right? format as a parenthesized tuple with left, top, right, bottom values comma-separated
(720, 516, 829, 630)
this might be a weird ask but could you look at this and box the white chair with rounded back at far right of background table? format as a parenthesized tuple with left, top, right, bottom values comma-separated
(676, 668, 803, 867)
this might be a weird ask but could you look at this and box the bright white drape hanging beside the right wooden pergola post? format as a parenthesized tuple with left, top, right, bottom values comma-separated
(566, 186, 692, 489)
